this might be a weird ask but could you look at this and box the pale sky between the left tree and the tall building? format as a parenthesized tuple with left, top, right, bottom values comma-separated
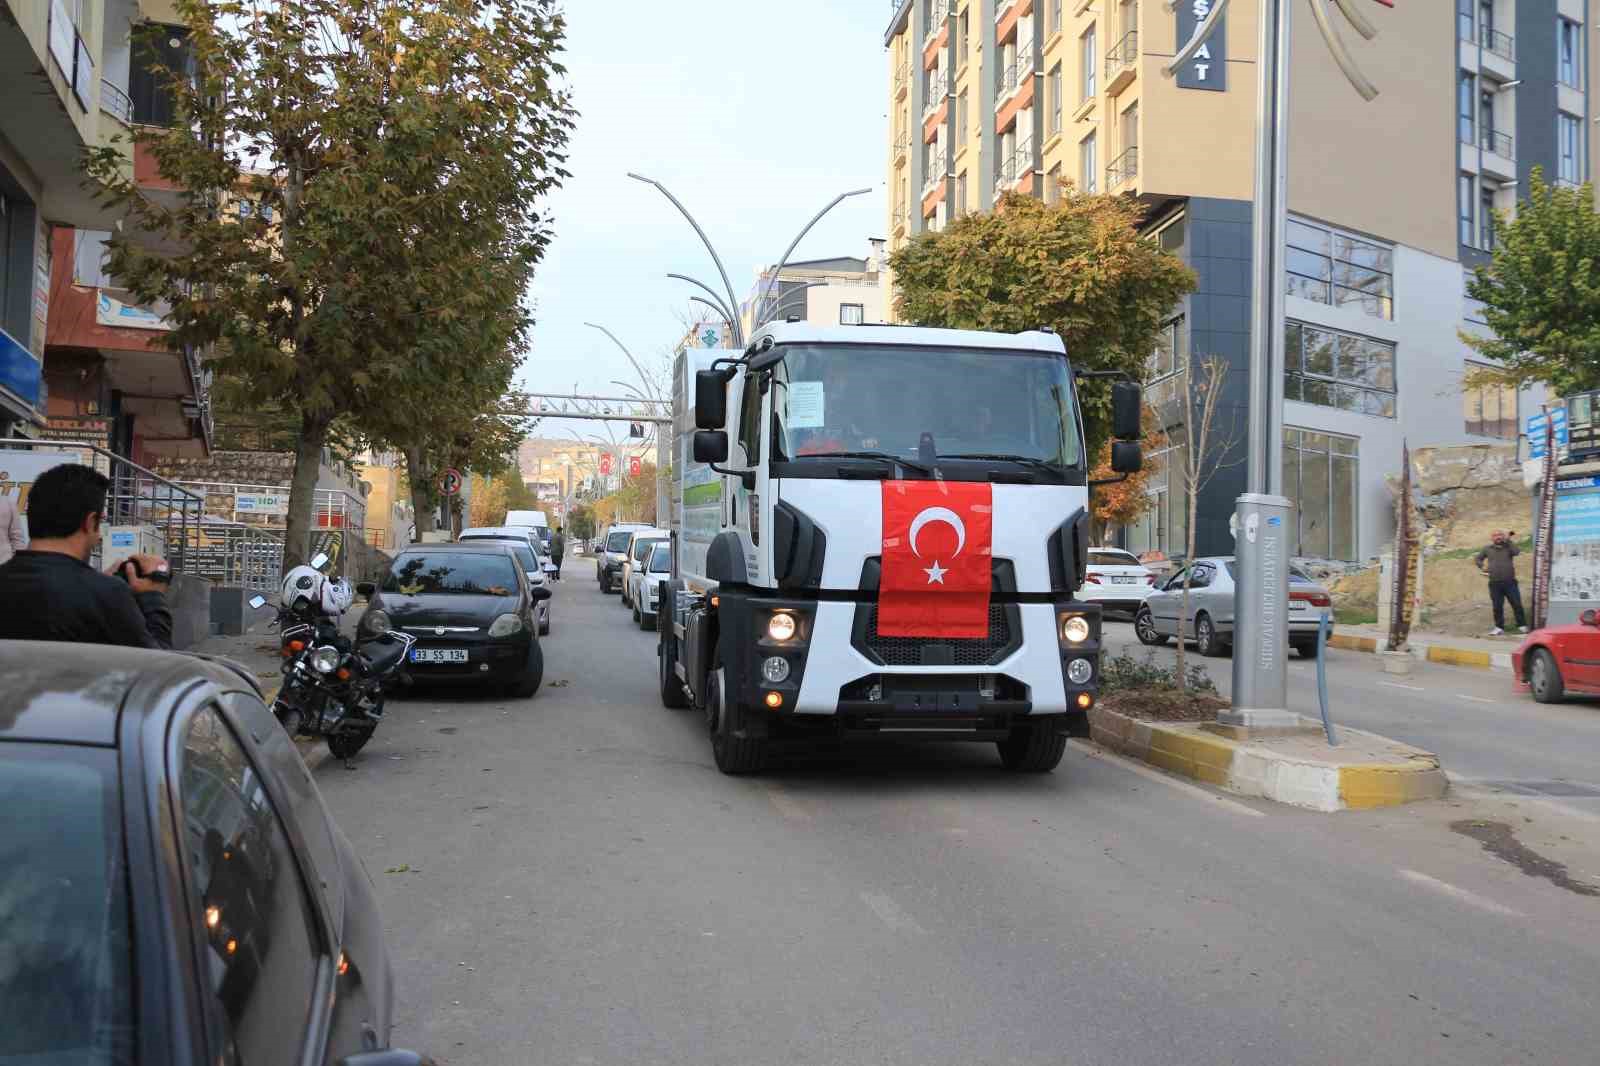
(520, 0, 893, 437)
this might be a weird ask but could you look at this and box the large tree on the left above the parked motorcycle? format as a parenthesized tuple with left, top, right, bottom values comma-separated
(88, 0, 573, 565)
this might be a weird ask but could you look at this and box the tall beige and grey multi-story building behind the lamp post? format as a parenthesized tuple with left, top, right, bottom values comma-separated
(885, 0, 1600, 560)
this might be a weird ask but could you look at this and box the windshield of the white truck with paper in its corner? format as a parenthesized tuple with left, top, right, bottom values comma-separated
(773, 344, 1083, 467)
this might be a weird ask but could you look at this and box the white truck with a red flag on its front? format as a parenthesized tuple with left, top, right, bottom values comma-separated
(658, 322, 1141, 773)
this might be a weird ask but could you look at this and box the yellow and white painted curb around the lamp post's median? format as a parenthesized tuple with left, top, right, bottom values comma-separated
(1090, 706, 1450, 812)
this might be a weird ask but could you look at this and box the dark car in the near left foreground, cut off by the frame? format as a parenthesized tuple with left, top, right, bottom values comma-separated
(0, 640, 427, 1066)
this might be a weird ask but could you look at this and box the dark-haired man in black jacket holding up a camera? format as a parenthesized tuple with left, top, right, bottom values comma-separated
(0, 463, 173, 648)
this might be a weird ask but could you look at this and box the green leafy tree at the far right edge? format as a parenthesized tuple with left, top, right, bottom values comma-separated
(1461, 166, 1600, 395)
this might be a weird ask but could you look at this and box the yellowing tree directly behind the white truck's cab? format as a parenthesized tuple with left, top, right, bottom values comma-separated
(890, 192, 1195, 455)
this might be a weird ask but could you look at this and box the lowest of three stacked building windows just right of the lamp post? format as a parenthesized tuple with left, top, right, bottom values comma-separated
(1283, 426, 1362, 562)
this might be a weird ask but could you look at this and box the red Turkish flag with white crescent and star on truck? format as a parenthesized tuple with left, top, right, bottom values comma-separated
(878, 480, 994, 639)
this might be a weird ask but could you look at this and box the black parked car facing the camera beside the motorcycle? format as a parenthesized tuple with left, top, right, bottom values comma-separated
(357, 541, 550, 696)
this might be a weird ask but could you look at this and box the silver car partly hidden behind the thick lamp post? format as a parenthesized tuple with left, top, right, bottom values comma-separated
(1133, 555, 1333, 656)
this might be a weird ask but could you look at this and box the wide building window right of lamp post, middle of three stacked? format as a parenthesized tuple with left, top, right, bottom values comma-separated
(1283, 322, 1395, 418)
